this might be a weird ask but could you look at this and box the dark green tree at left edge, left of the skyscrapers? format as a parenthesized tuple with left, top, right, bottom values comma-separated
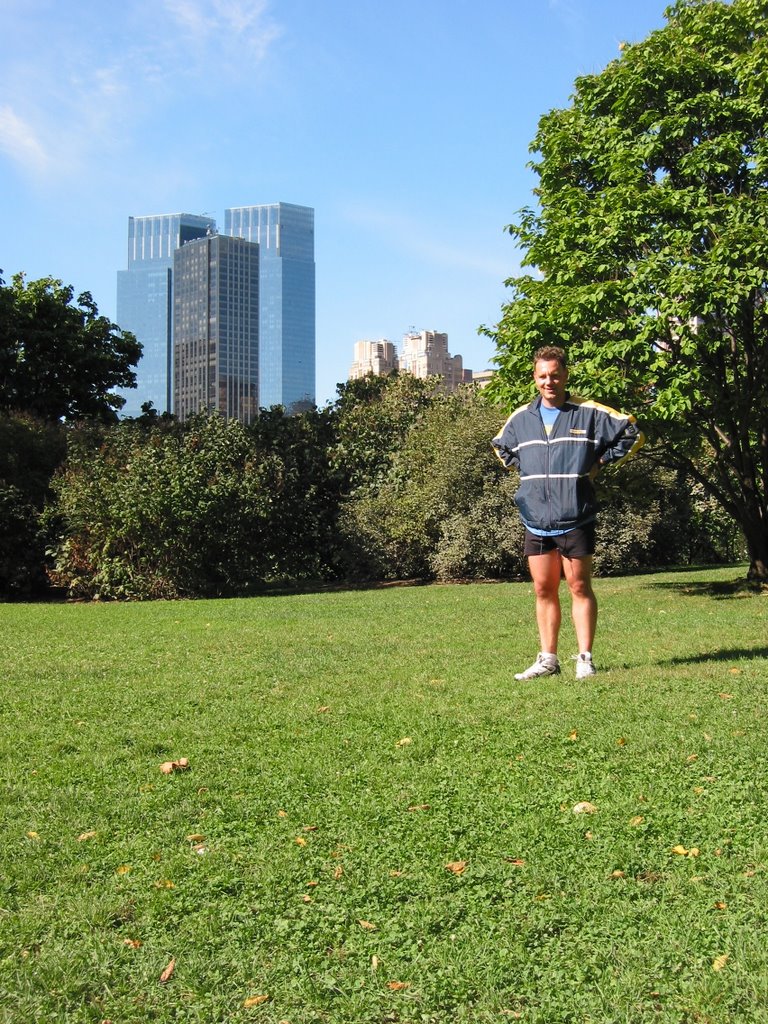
(0, 273, 141, 422)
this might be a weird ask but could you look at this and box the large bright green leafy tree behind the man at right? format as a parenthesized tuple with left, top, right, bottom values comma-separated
(487, 0, 768, 580)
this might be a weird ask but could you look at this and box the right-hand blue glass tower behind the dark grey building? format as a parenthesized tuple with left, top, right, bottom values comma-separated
(224, 203, 315, 413)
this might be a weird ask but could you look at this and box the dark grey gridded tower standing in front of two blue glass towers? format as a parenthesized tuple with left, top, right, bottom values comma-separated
(173, 234, 259, 423)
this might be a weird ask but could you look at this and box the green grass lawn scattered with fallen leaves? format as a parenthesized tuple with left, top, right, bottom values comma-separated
(0, 568, 768, 1024)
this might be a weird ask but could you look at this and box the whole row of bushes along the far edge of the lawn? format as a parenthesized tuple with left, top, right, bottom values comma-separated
(0, 375, 741, 599)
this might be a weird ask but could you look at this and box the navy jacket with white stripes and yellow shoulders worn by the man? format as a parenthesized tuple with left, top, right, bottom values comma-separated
(492, 394, 645, 529)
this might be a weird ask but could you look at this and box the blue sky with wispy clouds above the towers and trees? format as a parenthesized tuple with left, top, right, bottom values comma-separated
(0, 0, 667, 404)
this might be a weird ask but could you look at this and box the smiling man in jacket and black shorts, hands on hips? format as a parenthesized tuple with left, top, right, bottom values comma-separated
(492, 345, 645, 679)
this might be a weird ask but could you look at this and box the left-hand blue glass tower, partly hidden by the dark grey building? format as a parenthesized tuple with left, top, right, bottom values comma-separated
(117, 213, 216, 416)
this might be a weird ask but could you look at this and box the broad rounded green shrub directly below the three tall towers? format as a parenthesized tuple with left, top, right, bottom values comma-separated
(52, 416, 283, 598)
